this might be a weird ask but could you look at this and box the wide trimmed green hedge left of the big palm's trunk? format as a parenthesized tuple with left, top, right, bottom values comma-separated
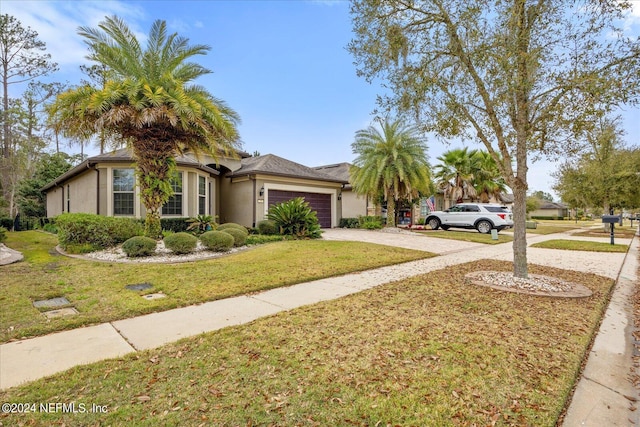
(55, 213, 144, 252)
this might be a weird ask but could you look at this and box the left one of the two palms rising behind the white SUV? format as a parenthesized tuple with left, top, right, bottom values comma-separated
(435, 147, 477, 202)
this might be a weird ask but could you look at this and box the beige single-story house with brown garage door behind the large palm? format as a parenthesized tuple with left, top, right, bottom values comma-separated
(42, 149, 348, 227)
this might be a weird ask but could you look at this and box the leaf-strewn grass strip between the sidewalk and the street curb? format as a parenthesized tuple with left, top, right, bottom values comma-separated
(0, 260, 614, 426)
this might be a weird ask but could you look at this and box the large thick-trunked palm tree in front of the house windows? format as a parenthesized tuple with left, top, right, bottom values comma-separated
(50, 16, 239, 238)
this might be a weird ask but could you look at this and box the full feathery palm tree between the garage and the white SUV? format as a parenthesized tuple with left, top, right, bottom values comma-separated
(350, 120, 431, 227)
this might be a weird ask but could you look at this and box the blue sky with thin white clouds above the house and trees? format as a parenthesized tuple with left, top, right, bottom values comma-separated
(0, 0, 640, 199)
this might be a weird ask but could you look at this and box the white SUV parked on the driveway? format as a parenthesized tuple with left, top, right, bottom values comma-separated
(426, 203, 513, 233)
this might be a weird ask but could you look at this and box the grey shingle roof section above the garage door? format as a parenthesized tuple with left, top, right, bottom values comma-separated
(228, 154, 348, 184)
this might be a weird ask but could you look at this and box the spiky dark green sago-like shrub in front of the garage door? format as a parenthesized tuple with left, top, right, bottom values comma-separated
(267, 197, 322, 239)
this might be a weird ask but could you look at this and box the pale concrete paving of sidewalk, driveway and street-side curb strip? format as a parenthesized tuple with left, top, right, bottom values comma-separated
(0, 229, 638, 426)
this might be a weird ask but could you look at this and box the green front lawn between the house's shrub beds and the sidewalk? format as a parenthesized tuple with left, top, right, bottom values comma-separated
(0, 231, 434, 342)
